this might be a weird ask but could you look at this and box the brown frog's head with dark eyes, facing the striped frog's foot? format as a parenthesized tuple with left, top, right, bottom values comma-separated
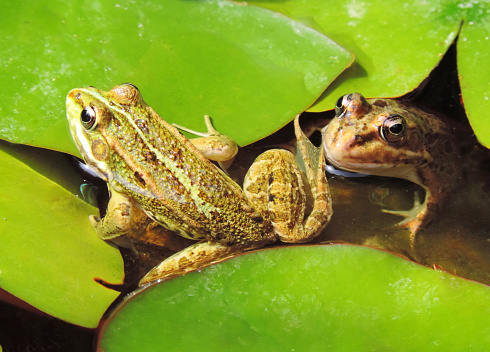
(323, 93, 430, 181)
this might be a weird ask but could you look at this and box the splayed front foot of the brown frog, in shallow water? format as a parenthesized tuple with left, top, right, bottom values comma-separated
(381, 192, 431, 245)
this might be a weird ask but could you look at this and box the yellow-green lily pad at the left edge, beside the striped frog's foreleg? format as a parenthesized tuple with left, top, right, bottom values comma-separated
(0, 146, 124, 328)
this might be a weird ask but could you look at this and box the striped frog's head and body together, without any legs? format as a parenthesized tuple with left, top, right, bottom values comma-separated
(67, 85, 274, 245)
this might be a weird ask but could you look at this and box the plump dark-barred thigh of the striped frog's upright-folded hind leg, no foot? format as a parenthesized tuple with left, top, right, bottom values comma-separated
(243, 149, 306, 242)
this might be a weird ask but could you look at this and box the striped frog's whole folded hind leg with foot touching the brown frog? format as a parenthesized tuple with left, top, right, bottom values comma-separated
(243, 118, 332, 243)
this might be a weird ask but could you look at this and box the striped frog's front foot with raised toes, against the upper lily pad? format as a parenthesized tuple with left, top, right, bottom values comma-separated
(172, 115, 238, 170)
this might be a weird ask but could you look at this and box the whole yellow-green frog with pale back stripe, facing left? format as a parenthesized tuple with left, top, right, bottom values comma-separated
(66, 84, 332, 284)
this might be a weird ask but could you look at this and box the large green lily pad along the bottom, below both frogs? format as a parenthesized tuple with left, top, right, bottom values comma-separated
(99, 245, 490, 352)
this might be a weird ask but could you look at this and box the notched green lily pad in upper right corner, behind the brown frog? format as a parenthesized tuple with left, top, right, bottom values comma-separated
(247, 0, 490, 147)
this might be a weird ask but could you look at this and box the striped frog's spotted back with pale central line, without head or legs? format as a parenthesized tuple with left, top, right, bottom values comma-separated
(106, 106, 264, 244)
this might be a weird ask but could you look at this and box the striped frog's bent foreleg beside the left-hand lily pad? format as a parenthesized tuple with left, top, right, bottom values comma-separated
(90, 191, 133, 240)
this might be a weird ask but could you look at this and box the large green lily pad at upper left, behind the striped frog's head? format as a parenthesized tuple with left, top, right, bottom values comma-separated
(0, 0, 352, 155)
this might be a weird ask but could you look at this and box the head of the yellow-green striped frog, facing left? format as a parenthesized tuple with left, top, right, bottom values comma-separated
(66, 83, 145, 181)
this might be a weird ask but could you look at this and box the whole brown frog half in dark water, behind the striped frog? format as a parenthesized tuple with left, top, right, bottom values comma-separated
(323, 93, 461, 243)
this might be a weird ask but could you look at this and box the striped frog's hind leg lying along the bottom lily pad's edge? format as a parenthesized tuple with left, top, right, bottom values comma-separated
(139, 241, 267, 286)
